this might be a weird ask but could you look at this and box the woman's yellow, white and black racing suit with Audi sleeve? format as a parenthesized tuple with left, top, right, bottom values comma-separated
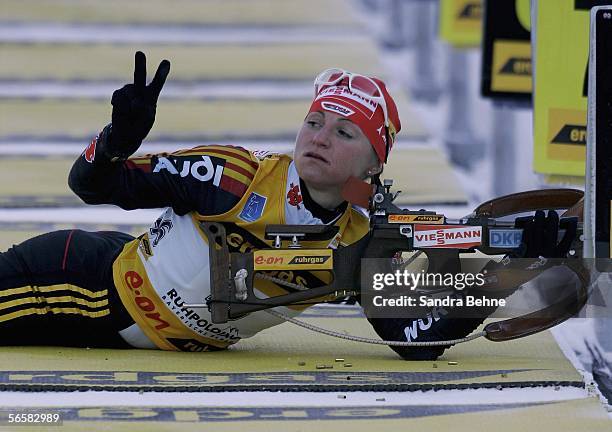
(0, 125, 492, 359)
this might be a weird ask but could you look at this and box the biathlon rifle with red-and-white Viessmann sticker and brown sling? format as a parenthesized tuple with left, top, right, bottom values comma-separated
(196, 180, 590, 341)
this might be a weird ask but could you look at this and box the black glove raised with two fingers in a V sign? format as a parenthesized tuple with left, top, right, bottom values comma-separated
(102, 51, 170, 161)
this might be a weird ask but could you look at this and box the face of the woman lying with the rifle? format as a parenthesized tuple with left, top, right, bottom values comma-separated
(293, 111, 378, 188)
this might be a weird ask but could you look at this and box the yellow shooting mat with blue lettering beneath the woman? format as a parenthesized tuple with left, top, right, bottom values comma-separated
(0, 306, 583, 391)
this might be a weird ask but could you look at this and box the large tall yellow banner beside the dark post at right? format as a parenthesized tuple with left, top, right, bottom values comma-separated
(532, 0, 601, 176)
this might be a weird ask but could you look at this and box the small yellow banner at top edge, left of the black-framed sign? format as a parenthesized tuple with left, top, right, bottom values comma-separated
(440, 0, 483, 47)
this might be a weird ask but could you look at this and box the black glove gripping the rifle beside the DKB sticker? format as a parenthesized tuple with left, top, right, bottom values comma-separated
(515, 210, 578, 258)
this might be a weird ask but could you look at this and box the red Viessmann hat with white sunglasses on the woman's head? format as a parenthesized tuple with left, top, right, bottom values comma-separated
(308, 69, 402, 162)
